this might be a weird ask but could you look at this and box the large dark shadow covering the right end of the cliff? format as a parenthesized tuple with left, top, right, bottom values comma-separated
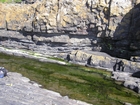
(103, 4, 140, 60)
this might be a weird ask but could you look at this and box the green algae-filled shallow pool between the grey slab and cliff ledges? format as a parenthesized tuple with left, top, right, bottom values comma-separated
(0, 54, 140, 105)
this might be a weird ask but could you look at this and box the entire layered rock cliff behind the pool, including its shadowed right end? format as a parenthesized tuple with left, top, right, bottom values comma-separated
(0, 0, 140, 59)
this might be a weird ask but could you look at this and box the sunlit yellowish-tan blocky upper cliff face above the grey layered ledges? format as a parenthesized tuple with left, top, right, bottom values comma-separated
(0, 0, 134, 37)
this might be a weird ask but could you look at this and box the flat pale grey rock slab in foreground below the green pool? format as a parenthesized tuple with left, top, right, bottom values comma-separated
(0, 72, 90, 105)
